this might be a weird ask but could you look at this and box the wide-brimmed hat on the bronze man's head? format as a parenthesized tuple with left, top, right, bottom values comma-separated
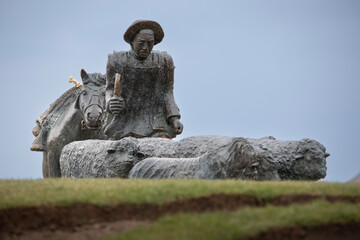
(124, 20, 164, 45)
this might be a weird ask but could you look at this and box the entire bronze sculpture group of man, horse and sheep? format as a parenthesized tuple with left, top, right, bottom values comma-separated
(31, 20, 329, 180)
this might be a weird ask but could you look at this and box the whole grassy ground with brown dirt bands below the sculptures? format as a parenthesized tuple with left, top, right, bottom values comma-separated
(0, 179, 360, 239)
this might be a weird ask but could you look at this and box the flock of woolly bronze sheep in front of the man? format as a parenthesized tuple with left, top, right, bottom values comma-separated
(60, 136, 328, 180)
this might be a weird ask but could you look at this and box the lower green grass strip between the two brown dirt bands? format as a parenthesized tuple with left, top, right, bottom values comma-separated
(106, 201, 360, 240)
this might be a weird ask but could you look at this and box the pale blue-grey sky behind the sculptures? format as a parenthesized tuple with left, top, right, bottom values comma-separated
(0, 0, 360, 181)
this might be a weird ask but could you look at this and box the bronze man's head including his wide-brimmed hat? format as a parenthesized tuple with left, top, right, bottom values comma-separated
(124, 20, 164, 59)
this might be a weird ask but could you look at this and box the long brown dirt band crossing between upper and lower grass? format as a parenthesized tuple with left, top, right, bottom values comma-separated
(0, 194, 360, 239)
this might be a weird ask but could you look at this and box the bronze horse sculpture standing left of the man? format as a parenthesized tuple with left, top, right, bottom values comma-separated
(30, 69, 106, 178)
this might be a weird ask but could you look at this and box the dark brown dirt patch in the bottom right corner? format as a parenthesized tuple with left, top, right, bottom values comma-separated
(243, 223, 360, 240)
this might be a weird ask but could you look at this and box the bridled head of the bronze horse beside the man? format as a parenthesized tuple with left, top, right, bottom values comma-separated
(75, 69, 106, 130)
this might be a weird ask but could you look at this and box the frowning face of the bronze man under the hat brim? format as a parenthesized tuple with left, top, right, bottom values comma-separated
(132, 29, 154, 59)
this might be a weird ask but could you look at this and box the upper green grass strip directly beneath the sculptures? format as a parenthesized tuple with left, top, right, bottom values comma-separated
(0, 179, 360, 209)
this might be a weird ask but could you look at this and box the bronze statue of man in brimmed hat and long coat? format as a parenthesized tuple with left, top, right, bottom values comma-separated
(105, 20, 183, 139)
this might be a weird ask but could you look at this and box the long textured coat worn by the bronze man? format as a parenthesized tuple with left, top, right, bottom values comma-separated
(105, 51, 180, 139)
